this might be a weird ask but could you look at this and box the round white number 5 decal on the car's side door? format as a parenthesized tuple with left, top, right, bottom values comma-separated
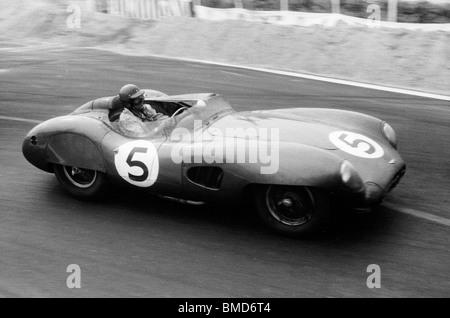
(114, 140, 159, 188)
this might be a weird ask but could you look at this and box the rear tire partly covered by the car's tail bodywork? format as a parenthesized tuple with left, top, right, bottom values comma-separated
(54, 165, 109, 201)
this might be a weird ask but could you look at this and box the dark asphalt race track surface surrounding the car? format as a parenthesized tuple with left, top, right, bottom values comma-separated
(0, 47, 450, 298)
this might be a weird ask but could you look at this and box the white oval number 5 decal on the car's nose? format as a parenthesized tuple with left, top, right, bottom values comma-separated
(329, 131, 384, 159)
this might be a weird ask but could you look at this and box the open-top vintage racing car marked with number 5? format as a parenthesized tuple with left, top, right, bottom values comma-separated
(23, 90, 406, 236)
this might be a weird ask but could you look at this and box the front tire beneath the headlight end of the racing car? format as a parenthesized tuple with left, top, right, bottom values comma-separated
(254, 185, 331, 237)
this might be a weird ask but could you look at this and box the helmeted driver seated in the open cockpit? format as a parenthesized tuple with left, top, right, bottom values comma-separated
(119, 84, 168, 137)
